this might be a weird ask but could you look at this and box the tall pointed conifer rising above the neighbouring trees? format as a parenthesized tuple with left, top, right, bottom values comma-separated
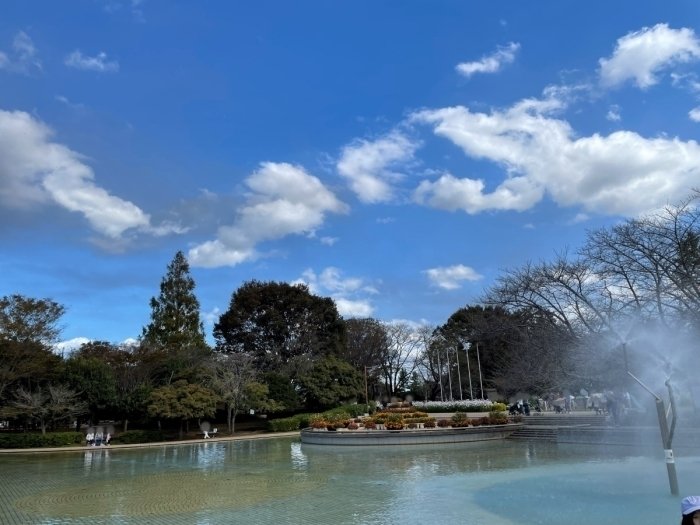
(142, 251, 206, 350)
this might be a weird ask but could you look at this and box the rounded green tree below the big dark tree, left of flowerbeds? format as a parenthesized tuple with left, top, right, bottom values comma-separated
(298, 355, 364, 410)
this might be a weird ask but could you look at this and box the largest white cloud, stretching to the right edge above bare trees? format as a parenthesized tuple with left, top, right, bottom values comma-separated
(412, 94, 700, 216)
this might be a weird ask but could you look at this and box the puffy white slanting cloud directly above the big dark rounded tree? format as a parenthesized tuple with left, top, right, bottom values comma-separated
(189, 162, 347, 268)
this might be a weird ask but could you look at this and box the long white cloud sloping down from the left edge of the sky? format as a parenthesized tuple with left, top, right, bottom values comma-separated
(0, 110, 183, 239)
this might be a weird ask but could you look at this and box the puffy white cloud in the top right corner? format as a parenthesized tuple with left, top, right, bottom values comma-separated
(599, 24, 700, 89)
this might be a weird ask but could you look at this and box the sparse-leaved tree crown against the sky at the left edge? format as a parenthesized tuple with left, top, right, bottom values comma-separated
(0, 294, 65, 346)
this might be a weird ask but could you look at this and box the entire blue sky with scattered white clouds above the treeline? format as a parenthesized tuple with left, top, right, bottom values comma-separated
(0, 0, 700, 348)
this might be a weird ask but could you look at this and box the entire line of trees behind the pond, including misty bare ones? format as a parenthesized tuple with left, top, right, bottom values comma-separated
(0, 194, 700, 432)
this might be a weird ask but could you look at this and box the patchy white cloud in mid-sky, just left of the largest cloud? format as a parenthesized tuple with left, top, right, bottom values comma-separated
(337, 131, 418, 203)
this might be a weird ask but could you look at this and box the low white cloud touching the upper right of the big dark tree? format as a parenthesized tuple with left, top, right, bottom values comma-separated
(292, 266, 378, 318)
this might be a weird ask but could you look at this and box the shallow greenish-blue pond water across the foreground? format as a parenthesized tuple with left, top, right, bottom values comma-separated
(0, 438, 700, 525)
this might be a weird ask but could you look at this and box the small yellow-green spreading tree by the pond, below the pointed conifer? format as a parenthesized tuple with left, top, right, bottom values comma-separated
(148, 380, 218, 439)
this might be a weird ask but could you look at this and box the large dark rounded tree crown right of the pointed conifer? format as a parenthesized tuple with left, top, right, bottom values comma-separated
(214, 281, 345, 378)
